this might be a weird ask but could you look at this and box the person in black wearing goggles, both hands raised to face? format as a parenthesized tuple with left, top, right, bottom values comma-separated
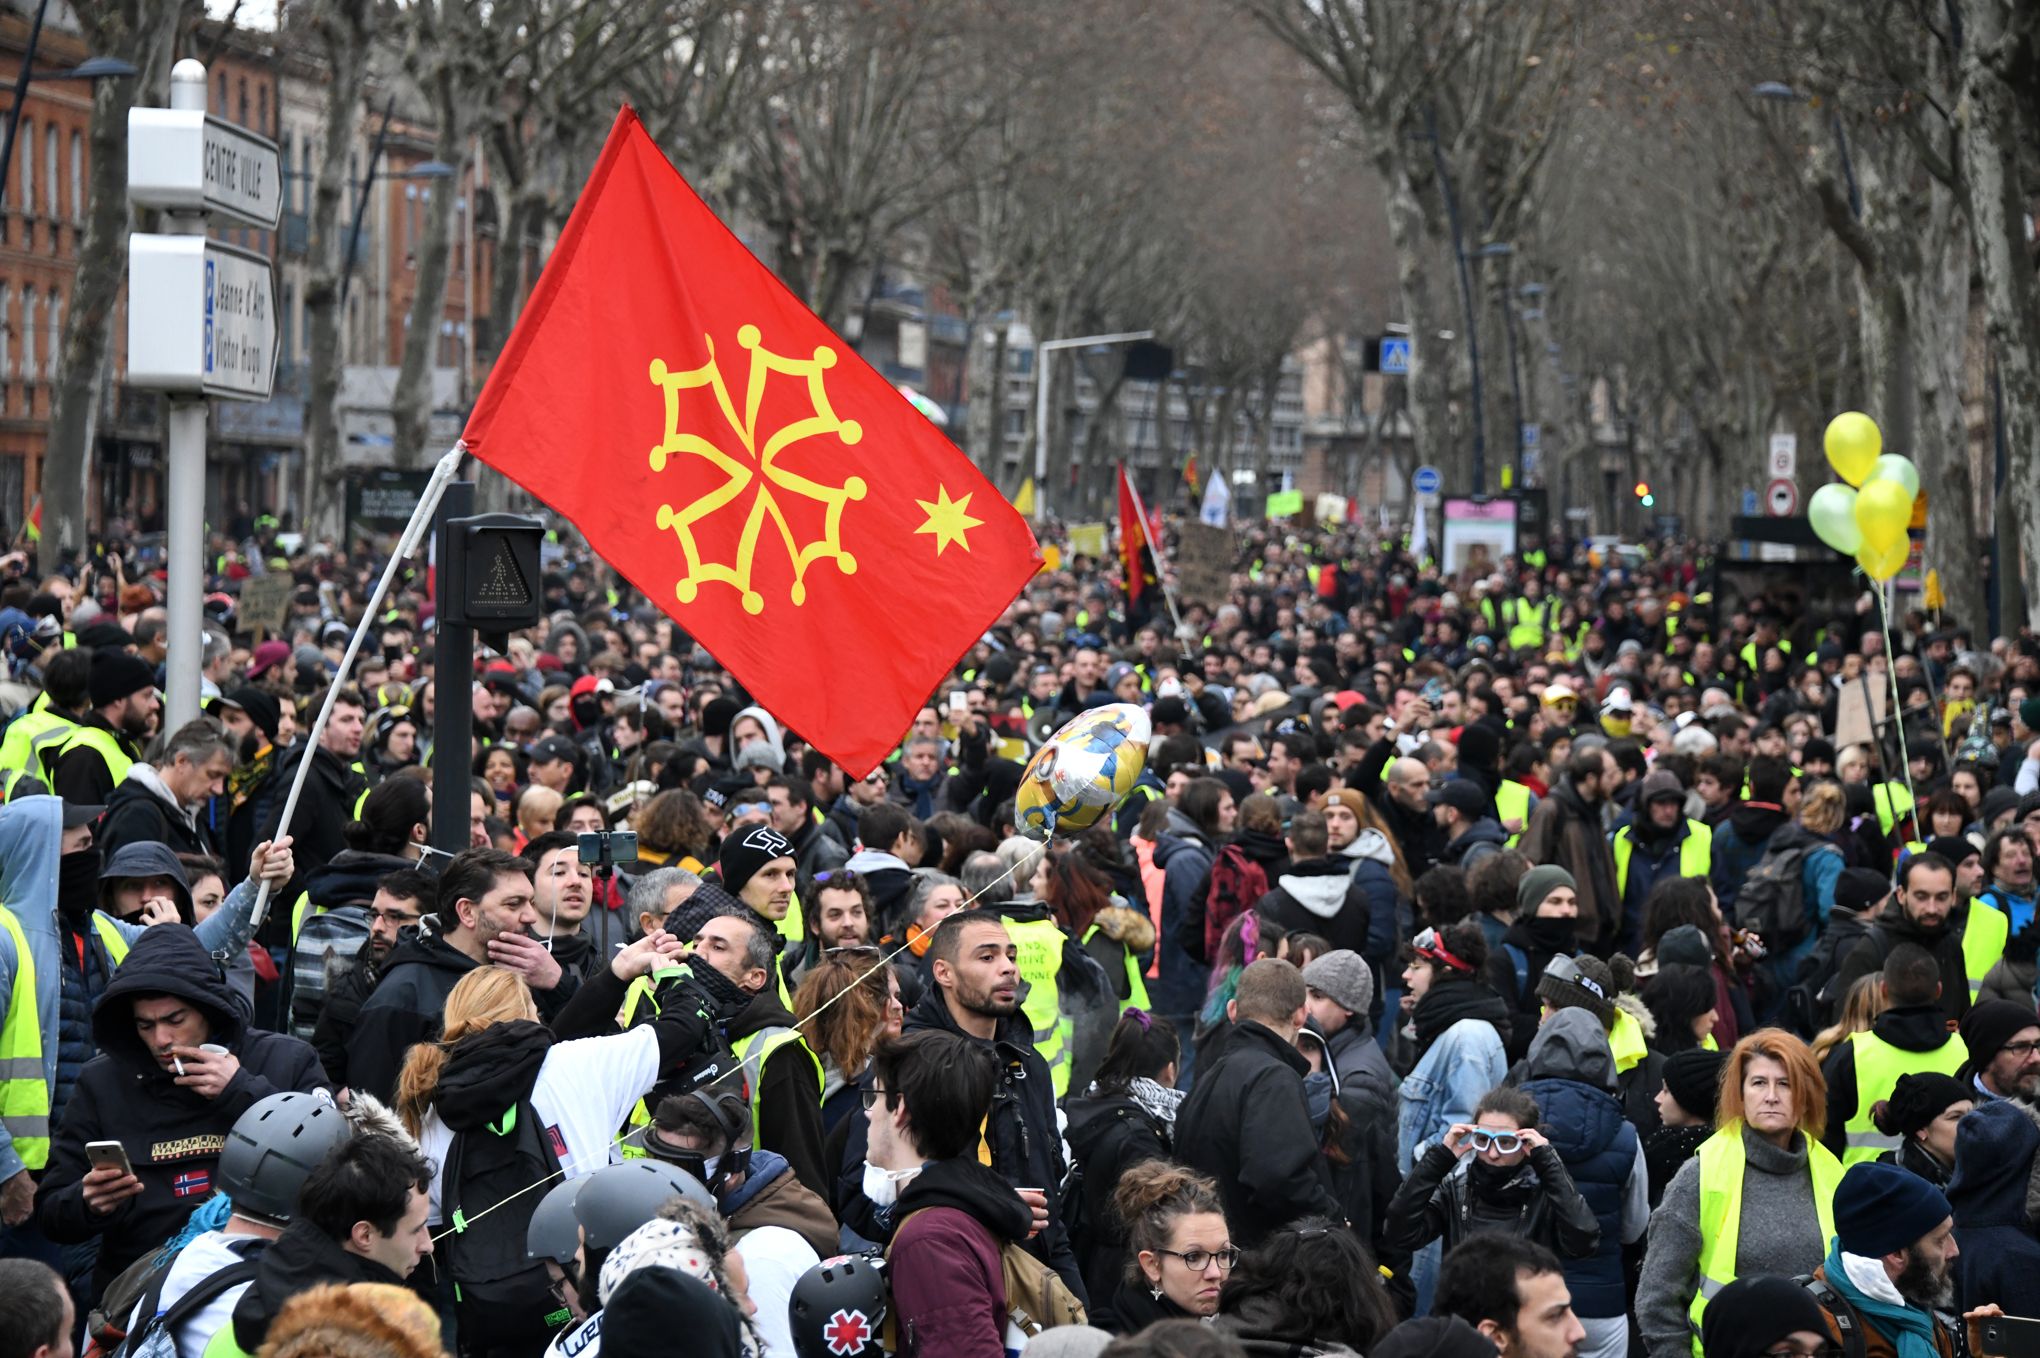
(1381, 1085, 1601, 1258)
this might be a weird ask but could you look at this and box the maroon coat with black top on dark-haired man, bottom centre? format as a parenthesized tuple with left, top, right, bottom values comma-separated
(885, 1156, 1036, 1358)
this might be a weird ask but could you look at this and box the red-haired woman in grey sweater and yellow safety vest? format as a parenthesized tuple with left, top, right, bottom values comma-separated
(1636, 1028, 1842, 1358)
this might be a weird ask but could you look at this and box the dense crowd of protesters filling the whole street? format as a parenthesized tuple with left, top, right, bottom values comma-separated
(0, 517, 2040, 1358)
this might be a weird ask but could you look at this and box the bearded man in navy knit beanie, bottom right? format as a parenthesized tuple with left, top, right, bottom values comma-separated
(1807, 1160, 1960, 1358)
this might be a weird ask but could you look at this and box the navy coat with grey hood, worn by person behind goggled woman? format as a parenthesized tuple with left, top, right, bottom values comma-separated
(1522, 1009, 1650, 1319)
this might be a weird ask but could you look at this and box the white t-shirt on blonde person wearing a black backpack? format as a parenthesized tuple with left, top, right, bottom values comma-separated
(418, 1024, 659, 1225)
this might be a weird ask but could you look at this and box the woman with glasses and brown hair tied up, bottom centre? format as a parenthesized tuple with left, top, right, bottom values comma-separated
(1093, 1160, 1240, 1334)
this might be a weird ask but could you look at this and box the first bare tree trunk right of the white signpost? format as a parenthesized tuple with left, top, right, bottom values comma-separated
(304, 0, 375, 540)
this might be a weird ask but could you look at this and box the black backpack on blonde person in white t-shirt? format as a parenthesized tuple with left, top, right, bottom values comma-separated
(441, 1095, 565, 1350)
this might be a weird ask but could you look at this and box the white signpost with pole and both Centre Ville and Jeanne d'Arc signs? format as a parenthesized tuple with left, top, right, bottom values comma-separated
(129, 59, 284, 730)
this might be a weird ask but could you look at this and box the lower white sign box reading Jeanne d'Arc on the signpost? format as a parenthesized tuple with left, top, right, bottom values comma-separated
(129, 234, 277, 402)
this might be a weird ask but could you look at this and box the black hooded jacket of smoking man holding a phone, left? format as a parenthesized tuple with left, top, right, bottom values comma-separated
(35, 924, 333, 1289)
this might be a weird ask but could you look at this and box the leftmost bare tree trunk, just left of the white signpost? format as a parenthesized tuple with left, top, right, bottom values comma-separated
(42, 6, 184, 573)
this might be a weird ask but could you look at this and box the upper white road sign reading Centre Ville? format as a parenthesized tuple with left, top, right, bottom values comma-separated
(129, 108, 284, 230)
